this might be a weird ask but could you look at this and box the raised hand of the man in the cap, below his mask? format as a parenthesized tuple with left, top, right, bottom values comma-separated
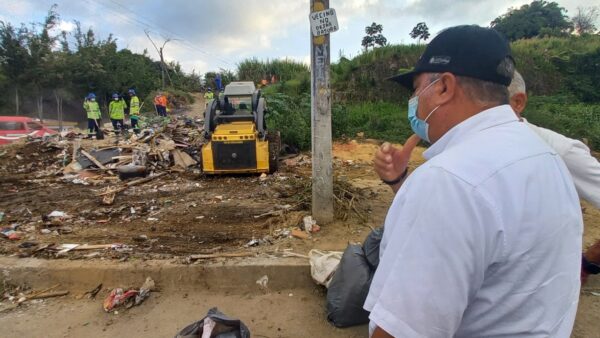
(374, 134, 421, 192)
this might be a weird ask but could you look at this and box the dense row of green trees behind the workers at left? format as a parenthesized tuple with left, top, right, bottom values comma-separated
(0, 6, 200, 120)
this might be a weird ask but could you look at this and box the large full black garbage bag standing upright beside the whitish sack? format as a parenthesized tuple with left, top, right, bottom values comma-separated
(327, 244, 374, 327)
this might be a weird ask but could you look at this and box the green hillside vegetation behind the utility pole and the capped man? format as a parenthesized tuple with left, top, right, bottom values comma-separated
(253, 35, 600, 149)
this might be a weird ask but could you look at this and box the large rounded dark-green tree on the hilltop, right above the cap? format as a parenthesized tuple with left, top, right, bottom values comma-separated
(490, 0, 573, 41)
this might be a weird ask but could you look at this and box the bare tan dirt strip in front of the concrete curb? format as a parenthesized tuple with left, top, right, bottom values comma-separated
(0, 289, 368, 338)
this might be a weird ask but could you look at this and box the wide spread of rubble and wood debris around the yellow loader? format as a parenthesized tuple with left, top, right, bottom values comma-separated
(0, 117, 380, 262)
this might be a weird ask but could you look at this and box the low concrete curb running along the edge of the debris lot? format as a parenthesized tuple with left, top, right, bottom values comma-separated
(0, 257, 316, 293)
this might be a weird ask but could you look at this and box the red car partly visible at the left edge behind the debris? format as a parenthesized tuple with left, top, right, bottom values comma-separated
(0, 116, 56, 145)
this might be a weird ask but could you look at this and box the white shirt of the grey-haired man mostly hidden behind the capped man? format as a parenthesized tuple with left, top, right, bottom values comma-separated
(523, 119, 600, 209)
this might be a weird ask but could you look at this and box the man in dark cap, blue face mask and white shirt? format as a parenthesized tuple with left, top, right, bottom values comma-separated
(365, 26, 582, 338)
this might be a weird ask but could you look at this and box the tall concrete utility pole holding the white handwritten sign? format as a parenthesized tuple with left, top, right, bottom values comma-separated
(310, 0, 333, 224)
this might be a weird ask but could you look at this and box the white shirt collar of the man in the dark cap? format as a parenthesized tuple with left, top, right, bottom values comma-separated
(423, 104, 519, 160)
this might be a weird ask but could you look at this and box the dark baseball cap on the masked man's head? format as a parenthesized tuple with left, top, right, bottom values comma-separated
(389, 25, 514, 90)
